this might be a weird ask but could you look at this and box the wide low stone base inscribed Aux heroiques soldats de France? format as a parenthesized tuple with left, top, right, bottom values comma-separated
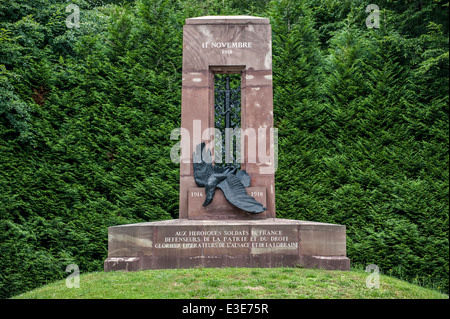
(104, 218, 350, 271)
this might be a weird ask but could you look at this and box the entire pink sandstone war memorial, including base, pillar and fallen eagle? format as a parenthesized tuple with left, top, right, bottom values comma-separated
(104, 16, 350, 271)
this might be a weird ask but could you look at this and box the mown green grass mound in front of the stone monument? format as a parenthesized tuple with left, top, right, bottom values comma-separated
(14, 268, 448, 299)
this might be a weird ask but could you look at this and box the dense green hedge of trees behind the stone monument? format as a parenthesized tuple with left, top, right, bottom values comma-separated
(0, 0, 449, 297)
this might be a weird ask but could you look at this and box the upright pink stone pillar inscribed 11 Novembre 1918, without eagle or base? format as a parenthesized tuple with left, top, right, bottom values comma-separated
(179, 16, 275, 219)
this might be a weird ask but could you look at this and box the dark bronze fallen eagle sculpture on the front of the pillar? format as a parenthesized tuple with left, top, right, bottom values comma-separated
(193, 142, 266, 214)
